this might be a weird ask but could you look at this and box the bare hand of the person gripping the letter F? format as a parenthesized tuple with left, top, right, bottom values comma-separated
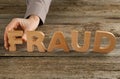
(4, 15, 40, 50)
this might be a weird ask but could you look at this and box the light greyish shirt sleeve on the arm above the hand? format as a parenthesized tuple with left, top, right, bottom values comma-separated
(25, 0, 51, 23)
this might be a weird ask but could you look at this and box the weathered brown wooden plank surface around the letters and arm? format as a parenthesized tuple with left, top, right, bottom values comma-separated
(0, 0, 120, 79)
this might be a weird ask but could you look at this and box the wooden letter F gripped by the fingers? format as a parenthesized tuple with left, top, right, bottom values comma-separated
(8, 31, 23, 51)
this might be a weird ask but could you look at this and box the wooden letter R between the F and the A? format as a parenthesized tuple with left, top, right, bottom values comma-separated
(27, 31, 46, 52)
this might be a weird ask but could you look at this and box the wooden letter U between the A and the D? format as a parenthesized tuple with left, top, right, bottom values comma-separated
(72, 31, 91, 52)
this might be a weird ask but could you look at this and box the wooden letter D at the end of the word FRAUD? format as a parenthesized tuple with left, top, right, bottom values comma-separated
(93, 31, 116, 53)
